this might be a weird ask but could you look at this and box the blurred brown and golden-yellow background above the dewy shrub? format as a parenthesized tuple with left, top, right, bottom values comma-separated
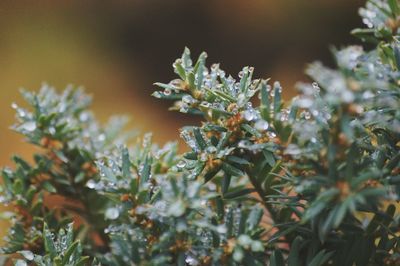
(0, 0, 364, 241)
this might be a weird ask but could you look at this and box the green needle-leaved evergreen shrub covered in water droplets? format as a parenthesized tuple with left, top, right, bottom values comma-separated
(1, 0, 400, 265)
